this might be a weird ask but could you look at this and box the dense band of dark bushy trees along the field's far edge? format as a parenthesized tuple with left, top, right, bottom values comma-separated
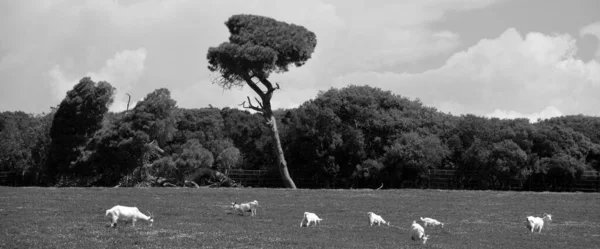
(0, 78, 600, 189)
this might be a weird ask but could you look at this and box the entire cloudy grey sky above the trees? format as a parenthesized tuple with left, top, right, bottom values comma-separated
(0, 0, 600, 120)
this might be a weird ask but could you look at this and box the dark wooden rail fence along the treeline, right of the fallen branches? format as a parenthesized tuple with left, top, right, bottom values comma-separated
(229, 169, 600, 192)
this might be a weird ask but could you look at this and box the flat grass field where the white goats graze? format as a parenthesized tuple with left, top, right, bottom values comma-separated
(0, 187, 600, 248)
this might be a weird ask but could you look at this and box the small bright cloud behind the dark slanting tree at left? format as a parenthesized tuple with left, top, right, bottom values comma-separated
(48, 48, 146, 111)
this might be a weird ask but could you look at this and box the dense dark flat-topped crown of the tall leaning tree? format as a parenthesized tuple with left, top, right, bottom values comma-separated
(207, 15, 317, 85)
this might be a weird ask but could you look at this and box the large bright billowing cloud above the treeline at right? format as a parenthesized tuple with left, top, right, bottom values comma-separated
(335, 26, 600, 117)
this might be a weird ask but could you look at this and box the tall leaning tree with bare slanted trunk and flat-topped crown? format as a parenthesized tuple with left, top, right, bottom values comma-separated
(207, 15, 317, 188)
